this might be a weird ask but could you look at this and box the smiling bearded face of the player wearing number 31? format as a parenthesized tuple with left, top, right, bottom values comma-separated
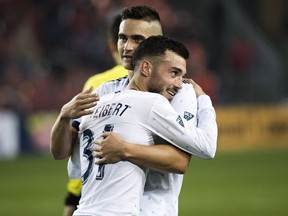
(148, 51, 186, 101)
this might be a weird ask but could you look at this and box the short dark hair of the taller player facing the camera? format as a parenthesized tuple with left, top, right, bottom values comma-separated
(121, 6, 160, 22)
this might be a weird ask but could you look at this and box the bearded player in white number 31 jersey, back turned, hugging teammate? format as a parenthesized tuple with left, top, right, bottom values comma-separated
(73, 36, 214, 216)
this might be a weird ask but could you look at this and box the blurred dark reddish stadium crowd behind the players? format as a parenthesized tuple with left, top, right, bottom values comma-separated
(0, 0, 281, 111)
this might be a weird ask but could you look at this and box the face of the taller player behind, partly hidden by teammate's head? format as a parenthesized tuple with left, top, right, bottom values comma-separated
(118, 19, 163, 70)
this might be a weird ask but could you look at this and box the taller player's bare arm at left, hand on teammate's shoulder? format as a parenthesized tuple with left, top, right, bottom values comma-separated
(50, 88, 99, 160)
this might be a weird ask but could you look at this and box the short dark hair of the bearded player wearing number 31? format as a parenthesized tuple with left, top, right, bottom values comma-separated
(132, 36, 189, 69)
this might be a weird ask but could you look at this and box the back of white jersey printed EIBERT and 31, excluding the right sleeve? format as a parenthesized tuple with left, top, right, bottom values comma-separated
(74, 90, 168, 216)
